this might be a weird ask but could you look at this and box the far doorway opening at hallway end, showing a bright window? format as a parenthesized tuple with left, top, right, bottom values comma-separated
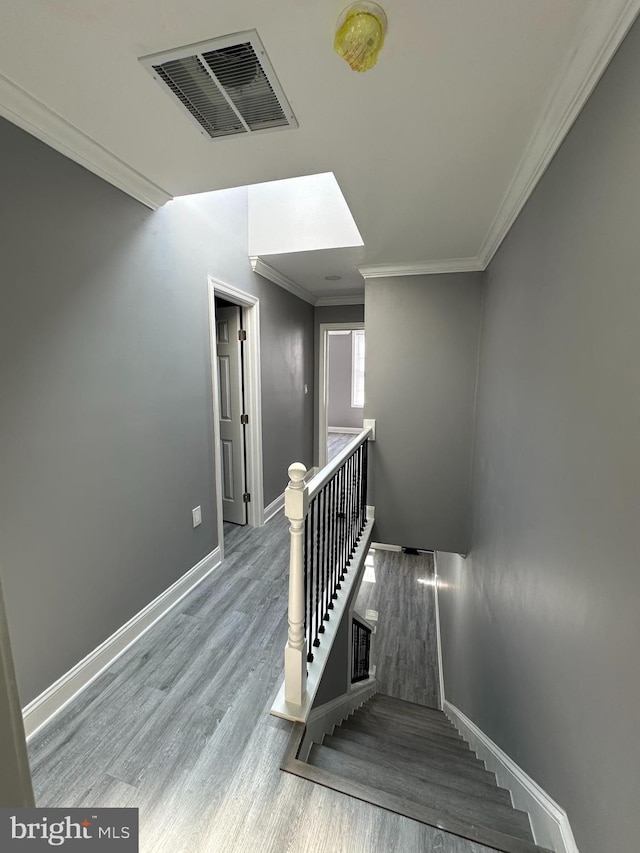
(318, 323, 365, 468)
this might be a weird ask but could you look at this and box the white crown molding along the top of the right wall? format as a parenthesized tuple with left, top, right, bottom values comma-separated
(479, 0, 640, 269)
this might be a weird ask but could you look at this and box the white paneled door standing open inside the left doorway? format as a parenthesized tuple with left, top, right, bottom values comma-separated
(216, 305, 247, 524)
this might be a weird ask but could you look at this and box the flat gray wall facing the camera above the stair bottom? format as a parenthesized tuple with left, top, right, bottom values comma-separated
(364, 273, 482, 552)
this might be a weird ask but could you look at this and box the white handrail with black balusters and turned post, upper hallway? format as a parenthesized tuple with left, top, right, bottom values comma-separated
(284, 422, 374, 705)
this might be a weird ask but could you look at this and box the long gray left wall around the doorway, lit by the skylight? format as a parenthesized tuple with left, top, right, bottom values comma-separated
(0, 121, 313, 705)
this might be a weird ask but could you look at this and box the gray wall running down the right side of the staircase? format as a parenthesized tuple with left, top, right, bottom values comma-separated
(438, 15, 640, 853)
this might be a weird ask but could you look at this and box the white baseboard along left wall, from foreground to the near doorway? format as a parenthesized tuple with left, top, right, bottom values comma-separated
(22, 547, 221, 739)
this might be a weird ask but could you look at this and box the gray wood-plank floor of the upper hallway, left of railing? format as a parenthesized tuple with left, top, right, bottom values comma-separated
(29, 515, 488, 853)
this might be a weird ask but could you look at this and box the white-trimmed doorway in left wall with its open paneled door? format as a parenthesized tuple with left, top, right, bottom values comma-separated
(209, 276, 264, 558)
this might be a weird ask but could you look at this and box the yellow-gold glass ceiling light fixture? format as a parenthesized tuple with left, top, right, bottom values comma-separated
(333, 2, 387, 71)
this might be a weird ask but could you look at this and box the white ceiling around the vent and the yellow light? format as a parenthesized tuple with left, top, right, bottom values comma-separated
(0, 0, 640, 295)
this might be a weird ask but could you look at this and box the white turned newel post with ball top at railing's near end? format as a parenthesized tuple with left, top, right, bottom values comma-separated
(284, 462, 309, 705)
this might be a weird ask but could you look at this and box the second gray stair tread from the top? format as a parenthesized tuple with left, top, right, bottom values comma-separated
(322, 735, 511, 807)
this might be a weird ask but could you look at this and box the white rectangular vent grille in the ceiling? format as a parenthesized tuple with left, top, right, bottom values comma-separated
(140, 30, 298, 139)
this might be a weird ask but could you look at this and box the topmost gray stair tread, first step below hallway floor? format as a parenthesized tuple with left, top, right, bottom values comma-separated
(308, 745, 533, 841)
